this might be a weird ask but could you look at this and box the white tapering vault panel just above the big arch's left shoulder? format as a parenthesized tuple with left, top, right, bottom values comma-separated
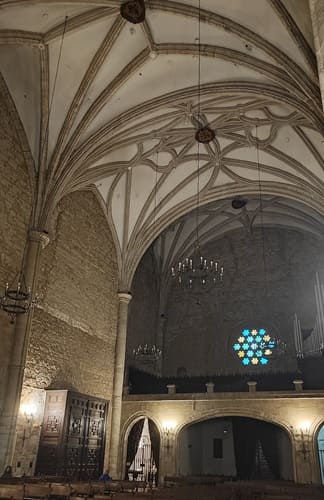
(129, 165, 161, 234)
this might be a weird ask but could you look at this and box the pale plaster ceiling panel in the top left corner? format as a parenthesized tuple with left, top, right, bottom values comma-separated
(0, 1, 96, 33)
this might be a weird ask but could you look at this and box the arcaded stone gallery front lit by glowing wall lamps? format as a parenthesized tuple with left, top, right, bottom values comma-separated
(120, 391, 324, 483)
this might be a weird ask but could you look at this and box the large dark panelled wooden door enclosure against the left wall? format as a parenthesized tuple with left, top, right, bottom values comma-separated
(36, 391, 108, 480)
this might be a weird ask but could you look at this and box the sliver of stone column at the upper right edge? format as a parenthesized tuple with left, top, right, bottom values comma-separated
(309, 0, 324, 110)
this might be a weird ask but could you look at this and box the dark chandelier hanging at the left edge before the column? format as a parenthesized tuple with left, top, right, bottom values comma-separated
(0, 272, 38, 323)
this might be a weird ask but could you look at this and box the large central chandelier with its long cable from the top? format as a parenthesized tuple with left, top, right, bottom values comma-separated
(171, 0, 224, 288)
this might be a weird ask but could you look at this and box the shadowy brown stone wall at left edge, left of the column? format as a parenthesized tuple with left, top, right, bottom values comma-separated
(0, 93, 32, 410)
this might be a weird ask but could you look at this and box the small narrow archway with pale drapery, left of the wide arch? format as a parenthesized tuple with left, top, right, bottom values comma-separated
(125, 417, 160, 485)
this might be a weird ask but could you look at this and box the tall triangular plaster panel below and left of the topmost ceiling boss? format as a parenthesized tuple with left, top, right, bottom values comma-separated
(49, 18, 113, 155)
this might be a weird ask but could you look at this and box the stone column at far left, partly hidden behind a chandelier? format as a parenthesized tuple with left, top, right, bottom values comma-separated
(0, 230, 49, 472)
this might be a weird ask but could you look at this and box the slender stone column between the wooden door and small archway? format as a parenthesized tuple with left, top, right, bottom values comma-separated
(109, 292, 132, 479)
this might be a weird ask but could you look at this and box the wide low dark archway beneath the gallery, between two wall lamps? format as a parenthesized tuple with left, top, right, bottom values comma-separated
(178, 416, 294, 480)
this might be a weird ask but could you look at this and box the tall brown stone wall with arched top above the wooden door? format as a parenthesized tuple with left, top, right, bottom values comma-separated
(14, 191, 118, 475)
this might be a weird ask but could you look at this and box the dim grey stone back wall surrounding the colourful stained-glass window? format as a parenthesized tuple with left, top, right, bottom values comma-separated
(163, 228, 324, 375)
